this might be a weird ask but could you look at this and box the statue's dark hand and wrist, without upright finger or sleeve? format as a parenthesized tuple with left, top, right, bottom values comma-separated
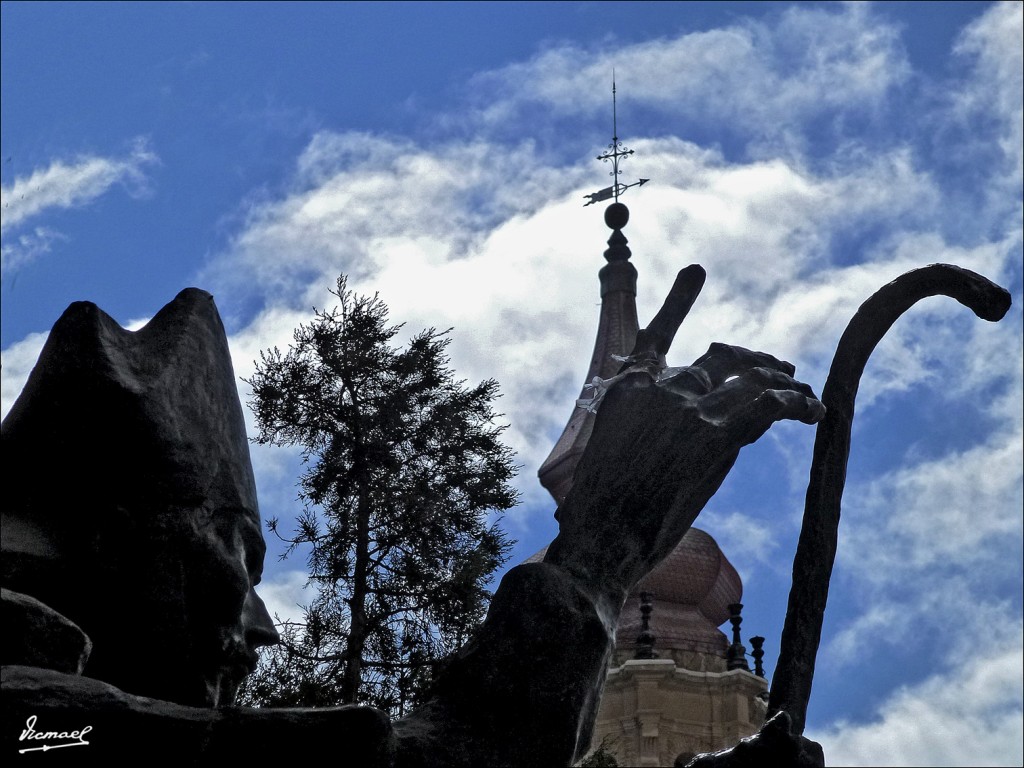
(545, 344, 824, 603)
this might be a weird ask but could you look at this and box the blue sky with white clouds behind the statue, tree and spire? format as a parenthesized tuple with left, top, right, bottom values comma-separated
(0, 2, 1024, 765)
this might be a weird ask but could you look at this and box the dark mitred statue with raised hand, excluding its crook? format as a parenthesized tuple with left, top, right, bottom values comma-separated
(2, 265, 1007, 768)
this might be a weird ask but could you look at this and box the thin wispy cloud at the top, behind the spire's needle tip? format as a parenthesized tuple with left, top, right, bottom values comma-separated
(460, 3, 909, 155)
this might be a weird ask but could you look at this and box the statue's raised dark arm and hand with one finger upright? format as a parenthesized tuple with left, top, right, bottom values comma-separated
(395, 266, 824, 766)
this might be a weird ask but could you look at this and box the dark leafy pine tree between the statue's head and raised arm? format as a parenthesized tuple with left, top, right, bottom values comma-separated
(240, 275, 517, 716)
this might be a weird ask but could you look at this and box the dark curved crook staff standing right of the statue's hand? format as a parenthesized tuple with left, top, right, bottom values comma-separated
(768, 264, 1010, 735)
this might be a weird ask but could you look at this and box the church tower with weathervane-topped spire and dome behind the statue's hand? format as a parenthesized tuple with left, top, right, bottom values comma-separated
(527, 75, 768, 765)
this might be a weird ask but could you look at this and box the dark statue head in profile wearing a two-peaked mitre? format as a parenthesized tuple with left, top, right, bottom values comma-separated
(0, 289, 276, 706)
